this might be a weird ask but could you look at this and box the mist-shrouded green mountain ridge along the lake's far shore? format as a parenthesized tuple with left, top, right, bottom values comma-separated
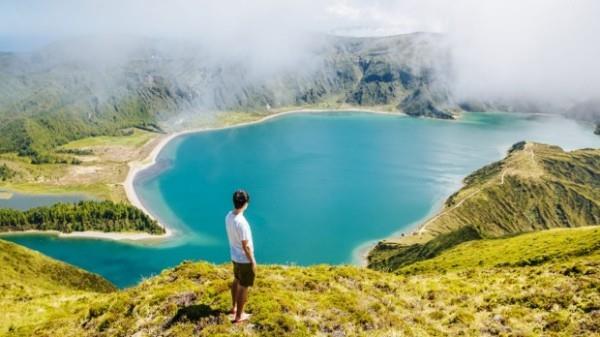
(0, 33, 460, 155)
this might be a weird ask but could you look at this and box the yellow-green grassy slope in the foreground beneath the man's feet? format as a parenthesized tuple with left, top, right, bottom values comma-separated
(0, 227, 600, 336)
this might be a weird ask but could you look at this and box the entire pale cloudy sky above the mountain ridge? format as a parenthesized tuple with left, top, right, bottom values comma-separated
(0, 0, 600, 102)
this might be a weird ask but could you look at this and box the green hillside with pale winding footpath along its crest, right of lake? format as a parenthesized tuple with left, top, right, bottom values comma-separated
(369, 142, 600, 270)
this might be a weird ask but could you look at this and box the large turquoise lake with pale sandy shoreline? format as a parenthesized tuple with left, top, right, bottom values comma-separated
(6, 112, 600, 287)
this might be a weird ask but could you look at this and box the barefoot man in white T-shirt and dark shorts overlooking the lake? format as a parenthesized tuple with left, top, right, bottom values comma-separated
(225, 190, 256, 323)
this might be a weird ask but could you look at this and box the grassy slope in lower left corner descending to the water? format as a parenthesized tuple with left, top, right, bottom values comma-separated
(0, 240, 115, 335)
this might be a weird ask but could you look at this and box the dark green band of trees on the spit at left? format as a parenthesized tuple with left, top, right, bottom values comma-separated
(0, 201, 165, 234)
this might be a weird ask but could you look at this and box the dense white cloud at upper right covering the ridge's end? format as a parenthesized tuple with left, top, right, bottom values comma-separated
(447, 0, 600, 104)
